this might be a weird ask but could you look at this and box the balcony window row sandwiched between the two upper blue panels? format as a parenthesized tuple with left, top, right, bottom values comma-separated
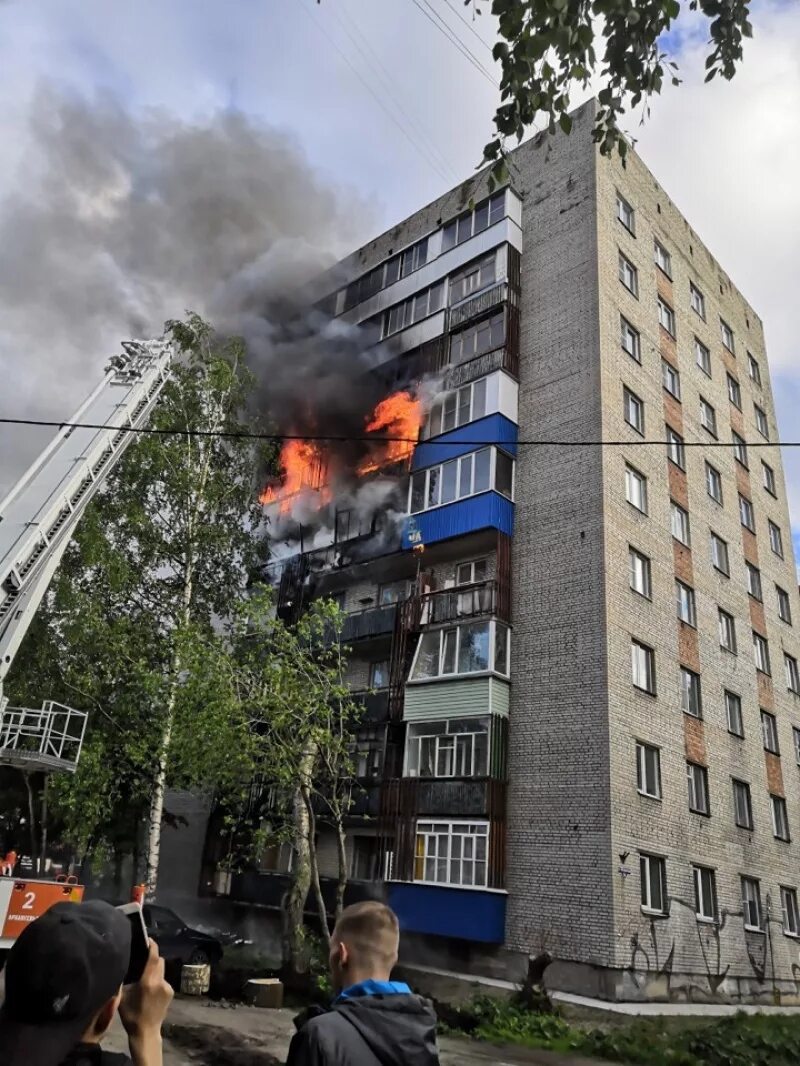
(409, 448, 514, 514)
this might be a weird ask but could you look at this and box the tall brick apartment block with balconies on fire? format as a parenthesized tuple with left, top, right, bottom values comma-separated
(199, 102, 800, 999)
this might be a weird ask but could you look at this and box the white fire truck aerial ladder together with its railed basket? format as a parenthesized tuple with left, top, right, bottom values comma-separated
(0, 340, 173, 773)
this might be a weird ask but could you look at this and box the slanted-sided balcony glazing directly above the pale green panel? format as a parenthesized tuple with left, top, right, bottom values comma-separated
(411, 621, 510, 681)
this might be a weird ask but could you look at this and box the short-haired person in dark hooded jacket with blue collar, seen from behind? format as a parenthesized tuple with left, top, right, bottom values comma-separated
(286, 900, 438, 1066)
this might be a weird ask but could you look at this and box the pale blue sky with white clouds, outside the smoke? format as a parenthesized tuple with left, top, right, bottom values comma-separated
(0, 0, 800, 567)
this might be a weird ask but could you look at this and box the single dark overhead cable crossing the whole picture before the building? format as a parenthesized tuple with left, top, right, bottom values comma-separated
(0, 418, 800, 449)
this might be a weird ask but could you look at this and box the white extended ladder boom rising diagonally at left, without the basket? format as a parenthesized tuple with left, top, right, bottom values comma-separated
(0, 340, 173, 707)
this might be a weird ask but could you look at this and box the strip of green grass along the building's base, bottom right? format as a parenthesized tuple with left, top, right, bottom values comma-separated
(448, 997, 800, 1066)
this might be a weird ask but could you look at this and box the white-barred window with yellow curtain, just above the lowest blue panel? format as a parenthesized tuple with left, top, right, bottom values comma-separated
(414, 822, 489, 887)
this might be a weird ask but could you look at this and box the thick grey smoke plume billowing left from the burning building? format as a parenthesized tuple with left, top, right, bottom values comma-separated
(0, 86, 394, 491)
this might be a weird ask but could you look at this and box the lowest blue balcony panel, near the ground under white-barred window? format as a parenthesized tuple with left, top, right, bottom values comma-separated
(389, 882, 507, 943)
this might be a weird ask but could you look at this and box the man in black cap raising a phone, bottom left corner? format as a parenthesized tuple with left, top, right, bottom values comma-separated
(0, 900, 173, 1066)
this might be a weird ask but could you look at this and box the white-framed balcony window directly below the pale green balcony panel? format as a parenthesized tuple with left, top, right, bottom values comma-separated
(405, 717, 489, 777)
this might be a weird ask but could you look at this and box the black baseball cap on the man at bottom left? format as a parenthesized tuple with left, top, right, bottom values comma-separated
(0, 900, 130, 1066)
